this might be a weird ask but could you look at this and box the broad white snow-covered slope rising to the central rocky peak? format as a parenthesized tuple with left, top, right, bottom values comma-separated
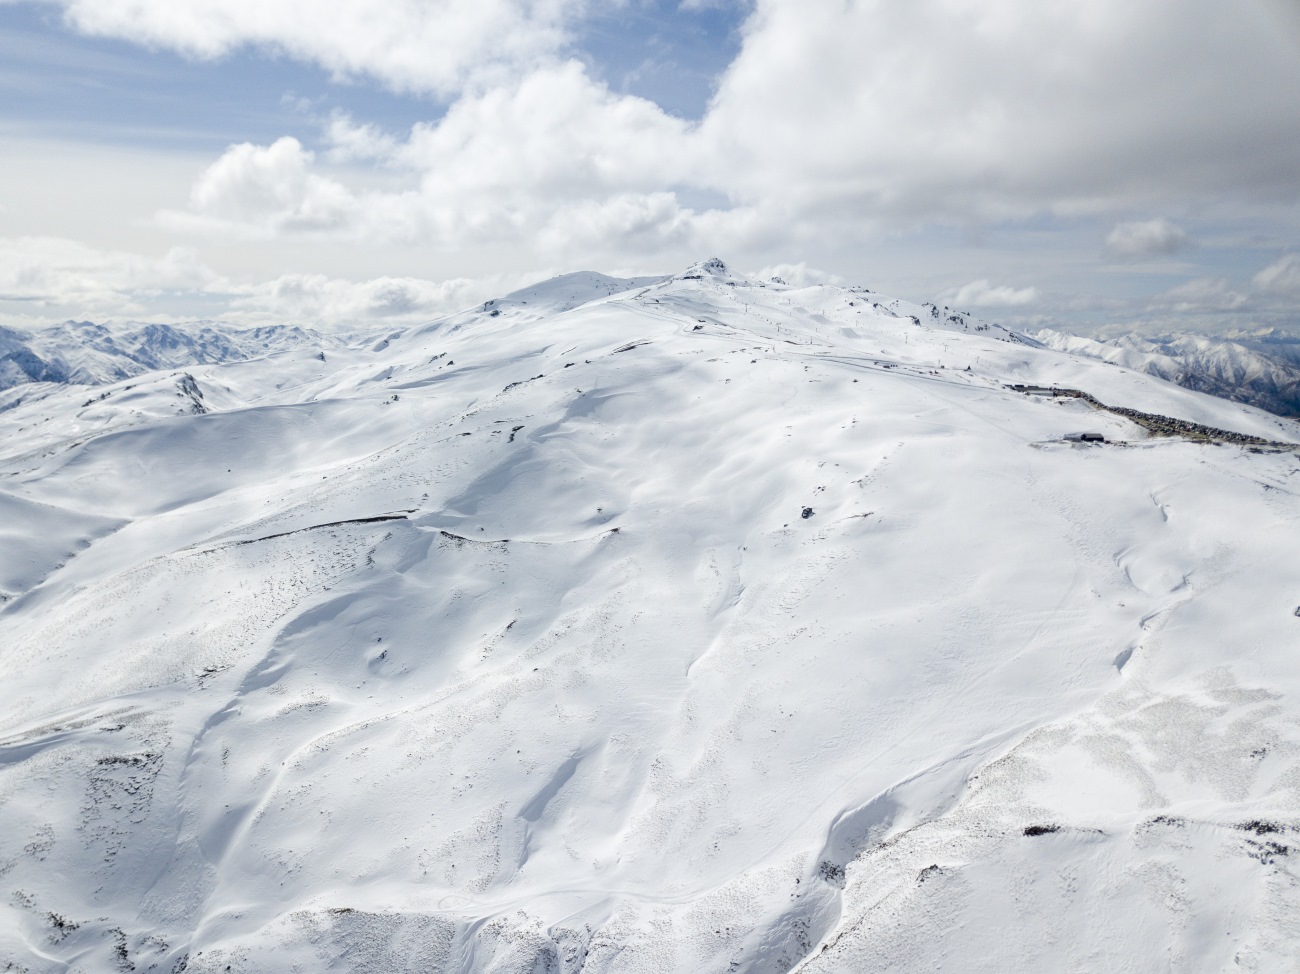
(0, 261, 1300, 974)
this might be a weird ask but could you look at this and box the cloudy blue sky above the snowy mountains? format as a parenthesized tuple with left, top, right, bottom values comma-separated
(0, 0, 1300, 334)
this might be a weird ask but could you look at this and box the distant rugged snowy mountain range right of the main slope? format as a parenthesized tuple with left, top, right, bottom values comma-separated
(1034, 329, 1300, 417)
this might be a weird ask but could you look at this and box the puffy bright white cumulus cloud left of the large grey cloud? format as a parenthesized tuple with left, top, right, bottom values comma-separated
(161, 61, 717, 259)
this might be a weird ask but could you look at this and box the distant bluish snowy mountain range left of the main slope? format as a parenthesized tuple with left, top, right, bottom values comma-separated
(0, 321, 343, 390)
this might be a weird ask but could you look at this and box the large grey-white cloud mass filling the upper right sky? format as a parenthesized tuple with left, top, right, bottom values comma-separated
(703, 0, 1300, 221)
